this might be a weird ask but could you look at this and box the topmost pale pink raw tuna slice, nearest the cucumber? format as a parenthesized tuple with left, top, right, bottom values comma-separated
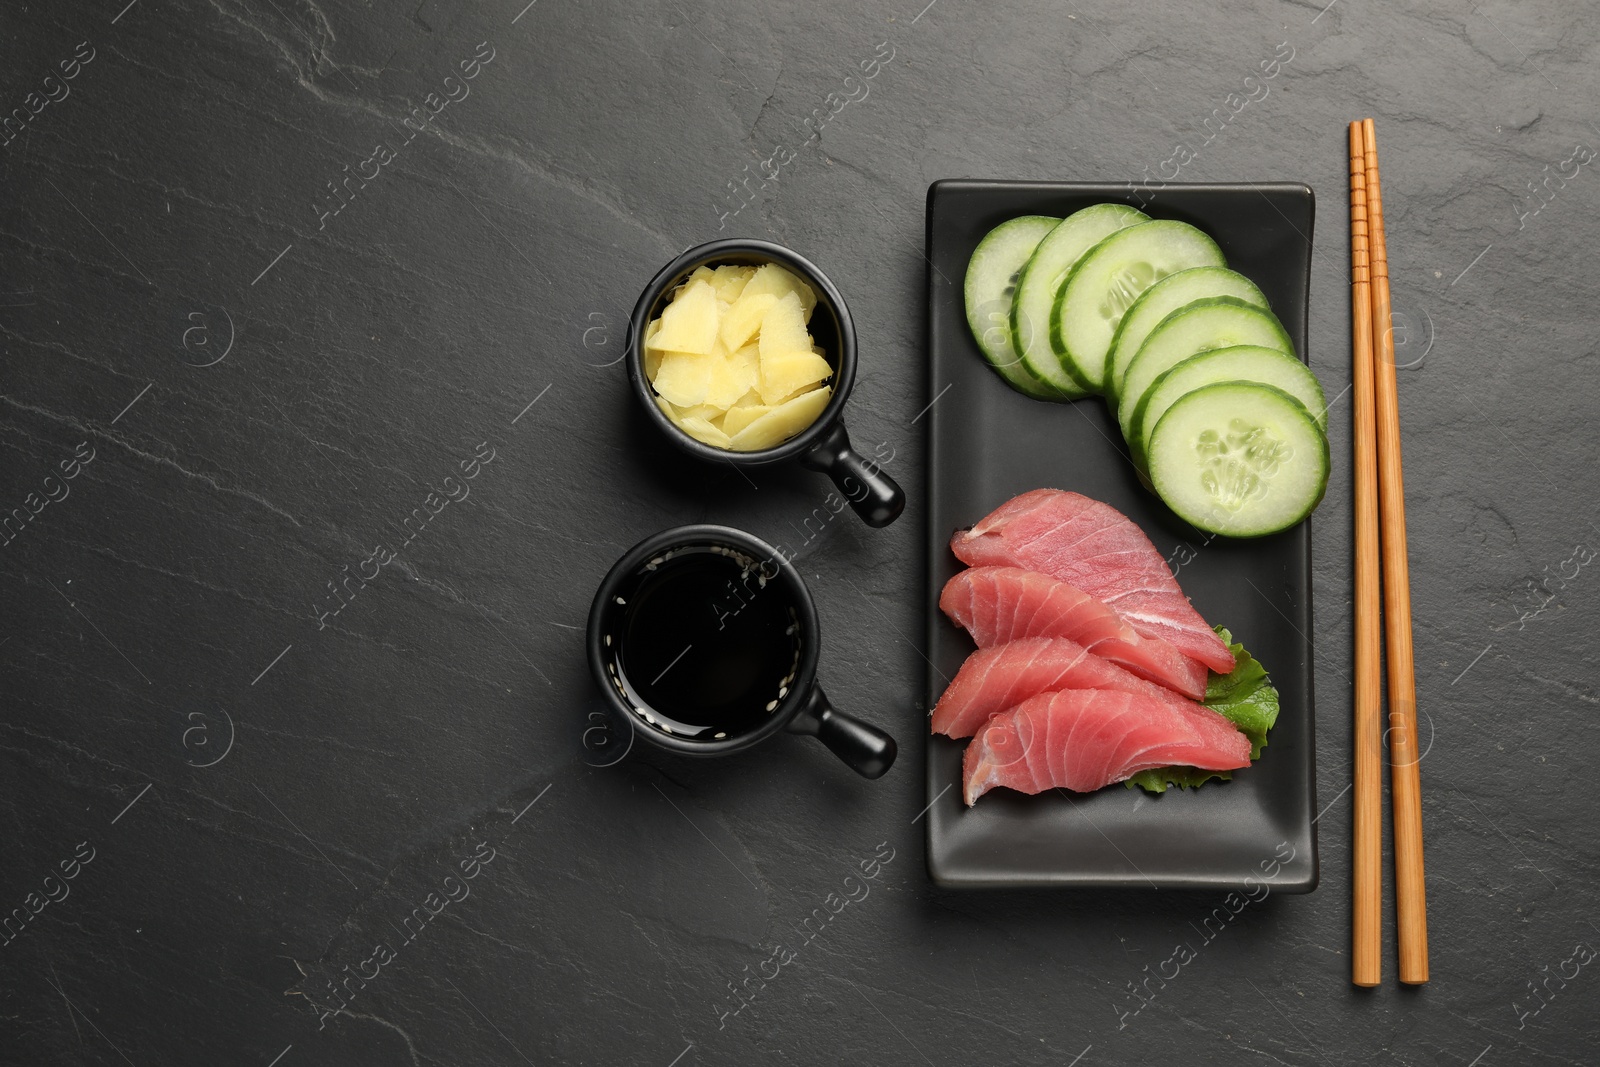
(950, 490, 1234, 673)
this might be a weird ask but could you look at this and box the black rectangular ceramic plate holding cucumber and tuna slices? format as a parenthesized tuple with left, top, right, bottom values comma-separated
(925, 179, 1317, 893)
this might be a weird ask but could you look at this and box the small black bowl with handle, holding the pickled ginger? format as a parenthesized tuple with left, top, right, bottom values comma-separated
(627, 238, 906, 526)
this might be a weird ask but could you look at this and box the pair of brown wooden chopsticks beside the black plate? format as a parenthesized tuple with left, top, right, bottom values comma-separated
(1350, 118, 1427, 985)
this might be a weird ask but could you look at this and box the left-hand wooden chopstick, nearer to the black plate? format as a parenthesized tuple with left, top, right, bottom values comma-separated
(1350, 122, 1384, 985)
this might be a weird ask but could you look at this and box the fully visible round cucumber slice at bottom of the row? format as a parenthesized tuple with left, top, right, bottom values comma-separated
(1150, 382, 1328, 537)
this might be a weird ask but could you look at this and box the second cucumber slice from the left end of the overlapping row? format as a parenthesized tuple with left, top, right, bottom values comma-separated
(1011, 203, 1150, 398)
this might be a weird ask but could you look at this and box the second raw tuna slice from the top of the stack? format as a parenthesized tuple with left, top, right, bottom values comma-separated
(939, 566, 1205, 701)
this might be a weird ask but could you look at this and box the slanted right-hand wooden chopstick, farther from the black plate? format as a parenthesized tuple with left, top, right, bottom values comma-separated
(1362, 118, 1427, 985)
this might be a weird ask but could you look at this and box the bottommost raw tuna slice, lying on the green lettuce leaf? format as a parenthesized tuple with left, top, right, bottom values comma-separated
(963, 689, 1250, 805)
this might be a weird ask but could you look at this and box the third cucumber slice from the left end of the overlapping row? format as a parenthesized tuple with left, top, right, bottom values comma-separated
(1050, 219, 1227, 392)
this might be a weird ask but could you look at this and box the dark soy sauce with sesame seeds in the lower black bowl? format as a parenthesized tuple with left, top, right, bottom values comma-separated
(614, 545, 802, 741)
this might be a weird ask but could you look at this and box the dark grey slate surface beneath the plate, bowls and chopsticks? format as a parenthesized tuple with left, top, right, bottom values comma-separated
(0, 0, 1600, 1067)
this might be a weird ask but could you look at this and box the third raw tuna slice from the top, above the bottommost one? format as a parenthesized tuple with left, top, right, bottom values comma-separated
(933, 637, 1190, 737)
